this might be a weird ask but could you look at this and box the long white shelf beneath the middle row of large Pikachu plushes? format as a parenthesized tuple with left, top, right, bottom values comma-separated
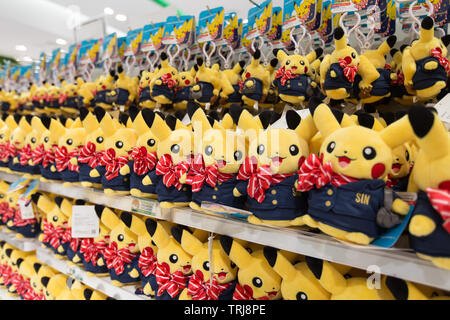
(0, 173, 450, 291)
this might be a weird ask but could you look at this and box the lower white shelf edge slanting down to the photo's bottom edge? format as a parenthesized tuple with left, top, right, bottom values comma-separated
(36, 247, 151, 300)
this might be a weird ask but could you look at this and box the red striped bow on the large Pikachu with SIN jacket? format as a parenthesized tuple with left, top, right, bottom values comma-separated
(297, 153, 359, 192)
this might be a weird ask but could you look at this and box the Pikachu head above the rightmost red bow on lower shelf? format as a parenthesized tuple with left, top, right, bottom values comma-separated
(220, 236, 281, 300)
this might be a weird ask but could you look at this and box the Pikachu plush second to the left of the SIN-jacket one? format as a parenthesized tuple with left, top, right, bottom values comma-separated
(187, 102, 247, 210)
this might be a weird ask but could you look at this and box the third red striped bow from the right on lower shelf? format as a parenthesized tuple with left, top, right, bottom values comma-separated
(155, 262, 187, 298)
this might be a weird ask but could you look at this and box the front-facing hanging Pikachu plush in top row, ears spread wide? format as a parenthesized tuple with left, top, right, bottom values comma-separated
(274, 48, 323, 106)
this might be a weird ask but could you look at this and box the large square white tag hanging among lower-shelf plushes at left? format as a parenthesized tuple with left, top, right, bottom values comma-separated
(72, 206, 100, 238)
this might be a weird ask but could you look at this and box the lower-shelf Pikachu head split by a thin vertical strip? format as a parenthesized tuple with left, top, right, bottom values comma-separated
(172, 227, 237, 283)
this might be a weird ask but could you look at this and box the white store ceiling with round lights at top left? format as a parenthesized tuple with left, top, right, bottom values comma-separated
(0, 0, 283, 60)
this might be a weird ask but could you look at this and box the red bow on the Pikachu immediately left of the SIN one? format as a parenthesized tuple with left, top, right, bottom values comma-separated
(237, 156, 293, 203)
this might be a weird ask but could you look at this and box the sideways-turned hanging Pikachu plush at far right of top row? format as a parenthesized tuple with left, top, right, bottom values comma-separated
(402, 17, 450, 100)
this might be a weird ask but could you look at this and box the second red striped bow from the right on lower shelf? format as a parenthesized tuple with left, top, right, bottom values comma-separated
(187, 270, 232, 300)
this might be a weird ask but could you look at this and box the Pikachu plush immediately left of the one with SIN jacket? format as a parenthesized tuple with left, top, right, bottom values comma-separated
(230, 106, 316, 226)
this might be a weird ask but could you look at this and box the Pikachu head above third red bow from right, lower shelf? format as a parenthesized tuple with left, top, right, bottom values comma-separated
(145, 219, 192, 275)
